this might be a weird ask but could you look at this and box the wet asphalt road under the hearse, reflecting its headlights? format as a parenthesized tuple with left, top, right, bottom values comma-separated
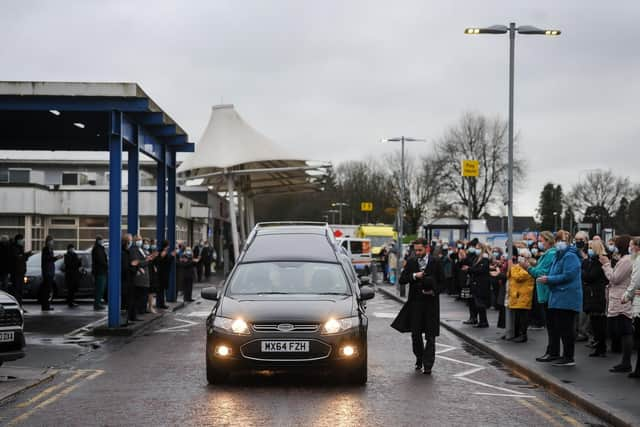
(0, 294, 602, 426)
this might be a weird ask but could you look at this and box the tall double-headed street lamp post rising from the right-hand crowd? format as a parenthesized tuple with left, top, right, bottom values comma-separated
(464, 22, 560, 338)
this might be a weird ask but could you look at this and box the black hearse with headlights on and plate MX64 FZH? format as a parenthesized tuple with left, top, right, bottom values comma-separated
(202, 223, 374, 384)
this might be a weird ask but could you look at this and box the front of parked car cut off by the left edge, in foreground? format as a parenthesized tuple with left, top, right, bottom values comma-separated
(0, 291, 25, 366)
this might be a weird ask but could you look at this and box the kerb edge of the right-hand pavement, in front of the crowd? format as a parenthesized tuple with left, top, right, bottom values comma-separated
(376, 286, 638, 427)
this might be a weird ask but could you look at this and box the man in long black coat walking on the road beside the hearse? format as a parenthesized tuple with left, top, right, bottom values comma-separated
(392, 239, 444, 375)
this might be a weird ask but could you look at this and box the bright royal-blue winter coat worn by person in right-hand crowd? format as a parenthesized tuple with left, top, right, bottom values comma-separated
(547, 246, 582, 313)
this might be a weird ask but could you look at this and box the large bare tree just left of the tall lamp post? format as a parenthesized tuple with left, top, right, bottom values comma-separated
(436, 113, 524, 218)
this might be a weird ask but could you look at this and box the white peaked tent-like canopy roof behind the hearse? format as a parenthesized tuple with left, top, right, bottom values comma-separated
(178, 104, 331, 194)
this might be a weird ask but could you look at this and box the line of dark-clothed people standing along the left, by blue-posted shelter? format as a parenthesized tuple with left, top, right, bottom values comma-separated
(0, 234, 216, 321)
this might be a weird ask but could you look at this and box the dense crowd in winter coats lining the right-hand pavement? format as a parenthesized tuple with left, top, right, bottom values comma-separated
(390, 230, 640, 378)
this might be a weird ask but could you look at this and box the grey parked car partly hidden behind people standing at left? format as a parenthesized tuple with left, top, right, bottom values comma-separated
(23, 251, 95, 298)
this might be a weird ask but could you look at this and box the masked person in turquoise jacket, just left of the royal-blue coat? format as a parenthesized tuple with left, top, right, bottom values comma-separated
(520, 231, 560, 362)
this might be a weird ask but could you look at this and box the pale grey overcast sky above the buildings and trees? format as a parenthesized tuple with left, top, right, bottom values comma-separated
(0, 0, 640, 214)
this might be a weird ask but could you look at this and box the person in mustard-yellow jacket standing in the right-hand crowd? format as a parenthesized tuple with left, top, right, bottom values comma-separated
(507, 248, 535, 343)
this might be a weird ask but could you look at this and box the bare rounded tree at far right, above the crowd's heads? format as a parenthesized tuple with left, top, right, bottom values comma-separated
(567, 169, 634, 217)
